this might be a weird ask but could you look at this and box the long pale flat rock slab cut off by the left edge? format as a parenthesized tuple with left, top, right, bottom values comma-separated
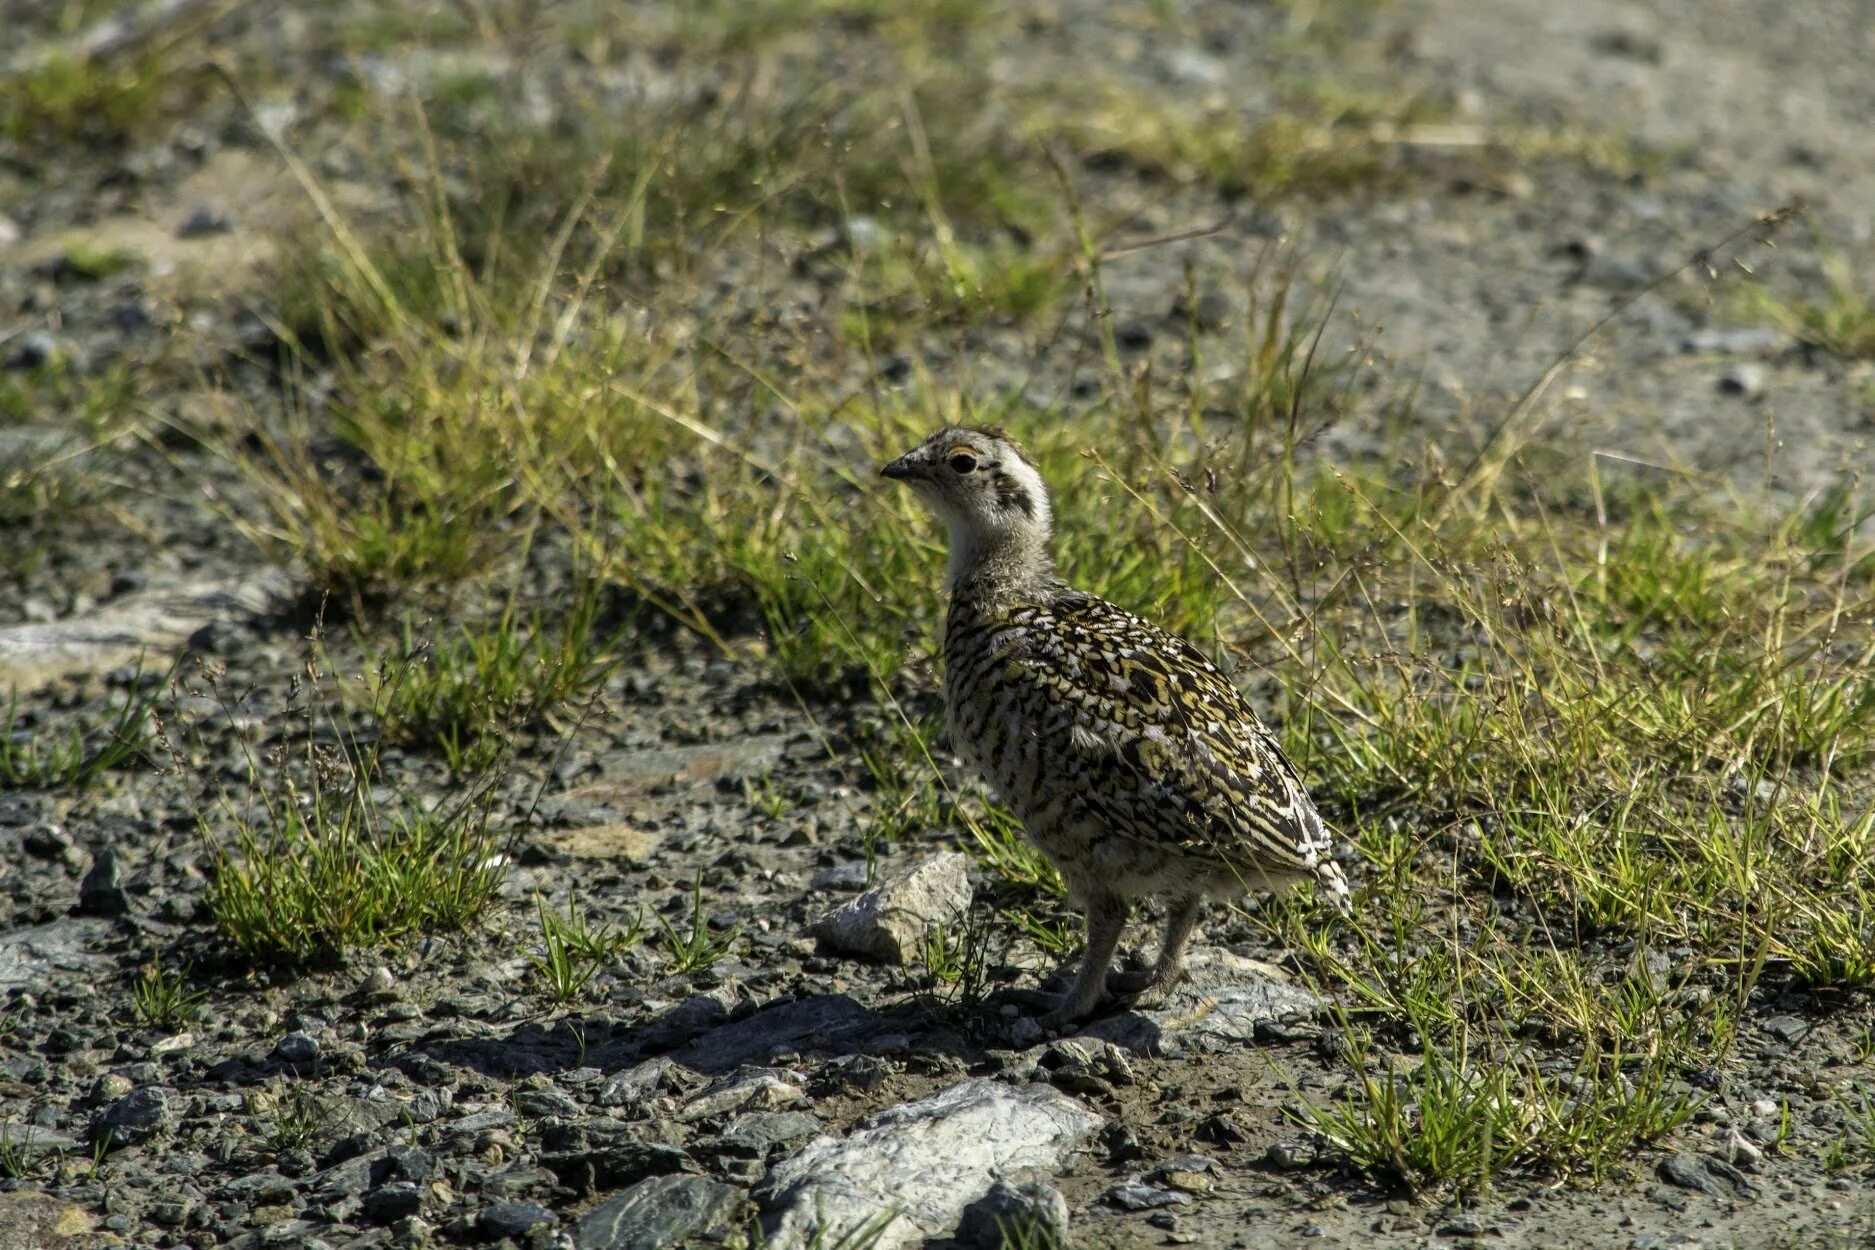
(0, 572, 291, 692)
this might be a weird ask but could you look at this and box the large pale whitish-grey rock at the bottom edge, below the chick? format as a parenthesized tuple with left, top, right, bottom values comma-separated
(763, 1079, 1104, 1250)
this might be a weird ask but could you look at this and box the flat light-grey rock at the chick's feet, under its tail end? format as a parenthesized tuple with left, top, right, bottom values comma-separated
(1080, 948, 1326, 1057)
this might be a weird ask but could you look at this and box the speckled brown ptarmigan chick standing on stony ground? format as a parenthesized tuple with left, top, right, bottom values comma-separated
(883, 425, 1348, 1027)
